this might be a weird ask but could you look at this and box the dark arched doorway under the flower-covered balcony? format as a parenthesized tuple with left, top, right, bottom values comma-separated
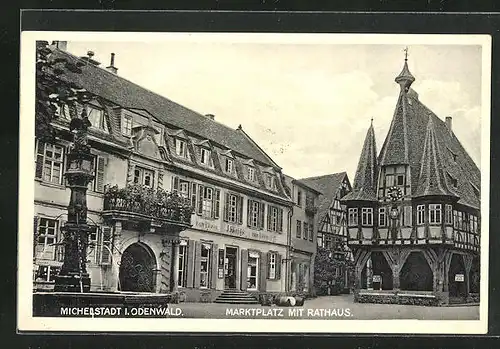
(118, 242, 157, 292)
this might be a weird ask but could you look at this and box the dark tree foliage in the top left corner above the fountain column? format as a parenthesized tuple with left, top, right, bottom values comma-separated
(35, 41, 88, 142)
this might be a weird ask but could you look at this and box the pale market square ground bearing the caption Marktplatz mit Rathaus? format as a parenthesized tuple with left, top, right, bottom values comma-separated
(171, 295, 479, 320)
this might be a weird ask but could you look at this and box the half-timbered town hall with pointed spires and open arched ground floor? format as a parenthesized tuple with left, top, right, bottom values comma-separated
(343, 58, 481, 303)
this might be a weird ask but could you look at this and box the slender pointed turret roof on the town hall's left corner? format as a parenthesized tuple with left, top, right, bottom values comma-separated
(343, 119, 378, 201)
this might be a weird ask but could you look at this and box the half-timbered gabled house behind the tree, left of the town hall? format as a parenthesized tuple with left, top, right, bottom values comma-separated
(300, 172, 351, 293)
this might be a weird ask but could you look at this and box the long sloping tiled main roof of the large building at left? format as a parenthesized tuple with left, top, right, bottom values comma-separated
(50, 49, 278, 167)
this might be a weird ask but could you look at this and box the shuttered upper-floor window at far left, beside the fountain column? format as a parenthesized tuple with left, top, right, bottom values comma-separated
(35, 141, 64, 184)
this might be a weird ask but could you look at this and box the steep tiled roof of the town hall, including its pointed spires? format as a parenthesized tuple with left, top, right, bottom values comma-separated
(343, 62, 481, 208)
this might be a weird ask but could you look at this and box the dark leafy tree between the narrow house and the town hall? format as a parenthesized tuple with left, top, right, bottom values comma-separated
(314, 243, 353, 295)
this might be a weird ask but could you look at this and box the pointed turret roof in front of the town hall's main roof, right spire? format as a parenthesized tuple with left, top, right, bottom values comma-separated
(415, 115, 456, 197)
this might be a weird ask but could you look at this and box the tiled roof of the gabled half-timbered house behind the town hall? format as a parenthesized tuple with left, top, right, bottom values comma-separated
(298, 172, 349, 219)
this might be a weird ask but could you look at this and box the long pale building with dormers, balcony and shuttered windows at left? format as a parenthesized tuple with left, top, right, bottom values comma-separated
(34, 41, 293, 301)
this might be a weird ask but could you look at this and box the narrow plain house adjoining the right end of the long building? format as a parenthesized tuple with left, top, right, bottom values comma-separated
(285, 175, 320, 293)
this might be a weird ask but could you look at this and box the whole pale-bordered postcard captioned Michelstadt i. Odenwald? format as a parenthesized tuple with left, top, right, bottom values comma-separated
(18, 32, 491, 334)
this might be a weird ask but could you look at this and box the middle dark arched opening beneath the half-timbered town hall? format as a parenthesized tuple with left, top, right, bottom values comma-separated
(399, 251, 434, 291)
